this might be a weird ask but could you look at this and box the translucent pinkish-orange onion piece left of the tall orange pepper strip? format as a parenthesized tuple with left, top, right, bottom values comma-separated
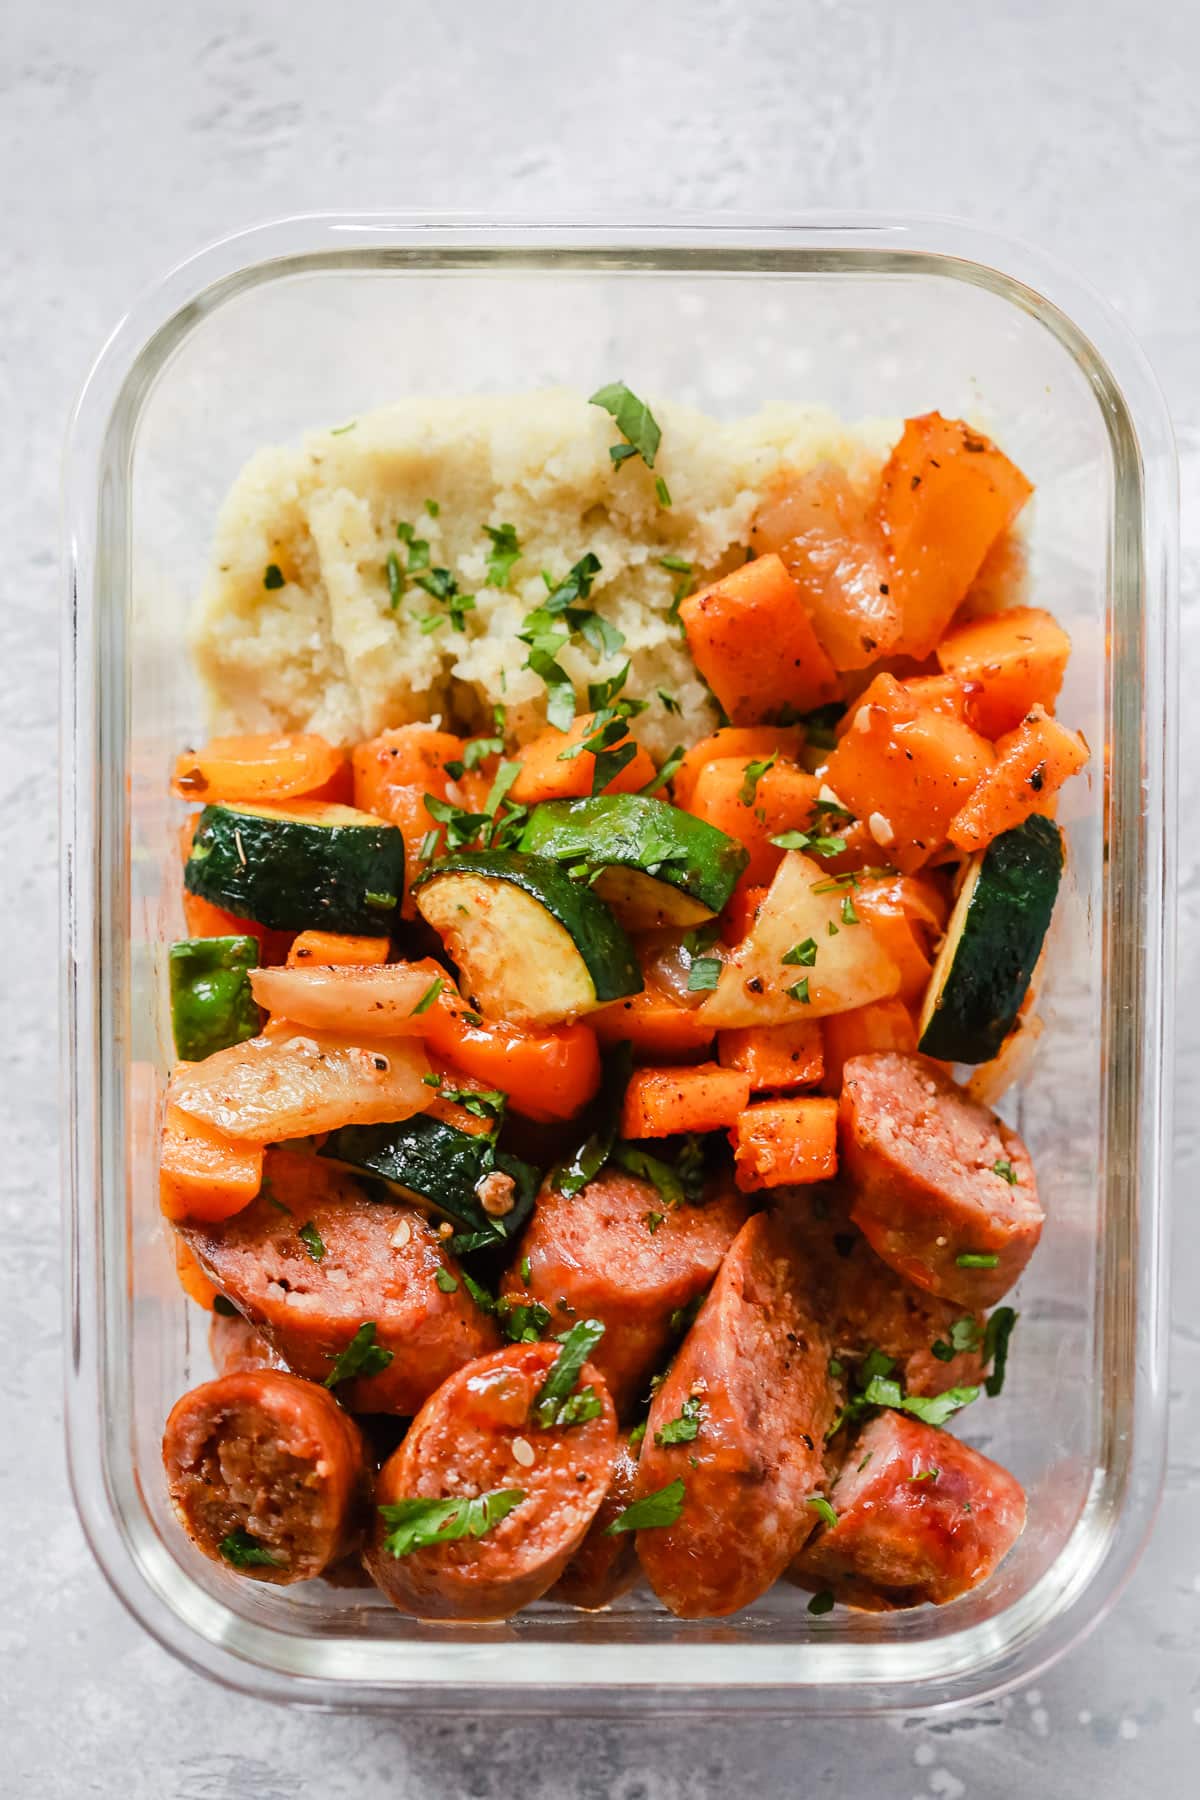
(750, 463, 901, 670)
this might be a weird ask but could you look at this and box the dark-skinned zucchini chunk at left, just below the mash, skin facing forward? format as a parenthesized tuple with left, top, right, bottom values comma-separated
(184, 799, 405, 936)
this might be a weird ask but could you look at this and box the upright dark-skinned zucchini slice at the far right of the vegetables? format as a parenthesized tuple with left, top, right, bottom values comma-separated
(918, 814, 1063, 1062)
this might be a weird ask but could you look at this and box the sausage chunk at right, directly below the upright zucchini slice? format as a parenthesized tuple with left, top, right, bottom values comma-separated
(840, 1051, 1045, 1307)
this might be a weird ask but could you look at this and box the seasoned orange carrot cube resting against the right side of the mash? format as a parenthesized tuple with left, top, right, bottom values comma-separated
(680, 556, 838, 725)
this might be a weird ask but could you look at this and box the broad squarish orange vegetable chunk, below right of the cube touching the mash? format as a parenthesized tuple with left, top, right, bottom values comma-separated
(826, 675, 995, 873)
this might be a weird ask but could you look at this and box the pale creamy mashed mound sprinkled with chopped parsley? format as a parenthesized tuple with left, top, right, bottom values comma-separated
(193, 389, 898, 754)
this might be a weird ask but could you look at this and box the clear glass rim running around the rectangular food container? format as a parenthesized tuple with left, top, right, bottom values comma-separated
(59, 212, 1178, 1715)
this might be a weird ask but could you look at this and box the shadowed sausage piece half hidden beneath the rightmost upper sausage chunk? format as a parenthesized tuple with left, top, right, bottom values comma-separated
(788, 1188, 984, 1395)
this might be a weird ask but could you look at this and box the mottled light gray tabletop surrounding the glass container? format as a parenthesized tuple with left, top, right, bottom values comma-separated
(0, 0, 1200, 1800)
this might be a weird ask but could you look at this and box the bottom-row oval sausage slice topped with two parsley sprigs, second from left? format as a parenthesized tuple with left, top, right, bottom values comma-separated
(367, 1343, 617, 1618)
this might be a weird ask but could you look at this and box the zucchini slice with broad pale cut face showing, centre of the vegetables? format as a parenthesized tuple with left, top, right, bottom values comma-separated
(412, 850, 642, 1026)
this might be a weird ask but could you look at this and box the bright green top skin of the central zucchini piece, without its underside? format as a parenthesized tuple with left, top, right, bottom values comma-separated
(520, 794, 750, 913)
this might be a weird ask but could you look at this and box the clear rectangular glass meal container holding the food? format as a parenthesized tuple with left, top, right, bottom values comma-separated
(63, 218, 1175, 1714)
